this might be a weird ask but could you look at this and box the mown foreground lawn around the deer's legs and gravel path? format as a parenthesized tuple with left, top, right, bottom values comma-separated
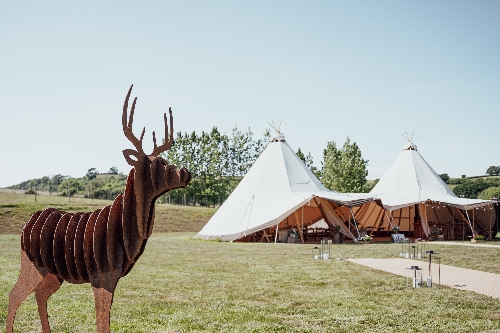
(0, 233, 500, 332)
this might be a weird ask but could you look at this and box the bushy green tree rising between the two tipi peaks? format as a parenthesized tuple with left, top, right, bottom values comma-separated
(321, 137, 368, 192)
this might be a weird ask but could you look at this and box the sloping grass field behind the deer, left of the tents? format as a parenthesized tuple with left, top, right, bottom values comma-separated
(0, 192, 216, 234)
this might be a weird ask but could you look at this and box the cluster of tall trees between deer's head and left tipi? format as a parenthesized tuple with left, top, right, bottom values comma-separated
(162, 127, 270, 206)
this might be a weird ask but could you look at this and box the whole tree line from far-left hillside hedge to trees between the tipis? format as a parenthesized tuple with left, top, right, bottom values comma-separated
(8, 127, 374, 206)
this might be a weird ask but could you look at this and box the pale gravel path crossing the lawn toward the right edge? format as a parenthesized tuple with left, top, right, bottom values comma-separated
(347, 258, 500, 298)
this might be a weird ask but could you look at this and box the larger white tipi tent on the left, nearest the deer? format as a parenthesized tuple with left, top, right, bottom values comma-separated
(195, 130, 373, 241)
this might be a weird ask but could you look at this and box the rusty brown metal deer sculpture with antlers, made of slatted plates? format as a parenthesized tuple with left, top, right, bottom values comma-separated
(6, 86, 191, 333)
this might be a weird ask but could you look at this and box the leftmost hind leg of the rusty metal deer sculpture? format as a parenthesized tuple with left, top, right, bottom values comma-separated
(5, 251, 43, 333)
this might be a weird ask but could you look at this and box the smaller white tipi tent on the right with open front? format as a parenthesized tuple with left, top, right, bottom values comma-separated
(355, 138, 495, 239)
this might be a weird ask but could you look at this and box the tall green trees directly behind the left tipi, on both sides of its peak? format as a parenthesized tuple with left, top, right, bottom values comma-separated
(162, 127, 373, 206)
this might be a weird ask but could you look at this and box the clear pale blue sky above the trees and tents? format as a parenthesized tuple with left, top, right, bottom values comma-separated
(0, 0, 500, 187)
